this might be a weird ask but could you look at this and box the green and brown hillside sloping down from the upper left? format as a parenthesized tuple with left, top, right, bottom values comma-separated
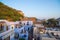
(0, 2, 24, 21)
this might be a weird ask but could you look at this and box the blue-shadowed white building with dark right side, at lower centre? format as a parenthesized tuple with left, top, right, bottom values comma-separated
(14, 21, 33, 40)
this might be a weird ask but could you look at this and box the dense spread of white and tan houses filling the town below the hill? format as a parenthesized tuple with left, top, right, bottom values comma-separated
(0, 17, 60, 40)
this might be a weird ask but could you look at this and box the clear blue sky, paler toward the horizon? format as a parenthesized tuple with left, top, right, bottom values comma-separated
(0, 0, 60, 19)
